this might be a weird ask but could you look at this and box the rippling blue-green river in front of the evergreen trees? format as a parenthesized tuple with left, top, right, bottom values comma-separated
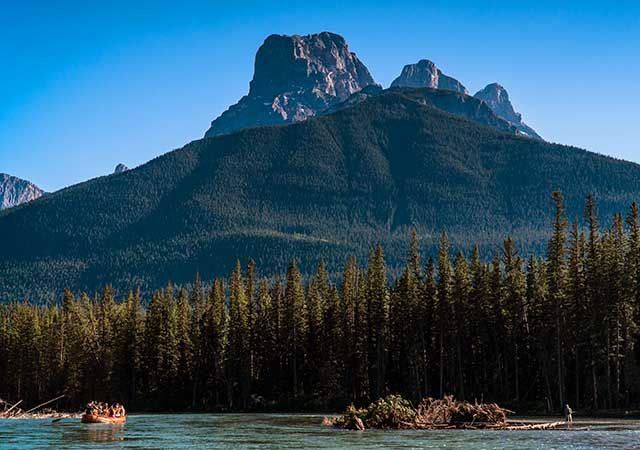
(0, 414, 640, 450)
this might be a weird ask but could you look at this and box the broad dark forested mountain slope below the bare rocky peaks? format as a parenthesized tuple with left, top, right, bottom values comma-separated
(0, 89, 640, 301)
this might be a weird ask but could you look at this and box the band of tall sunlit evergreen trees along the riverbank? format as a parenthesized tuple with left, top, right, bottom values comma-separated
(0, 193, 640, 410)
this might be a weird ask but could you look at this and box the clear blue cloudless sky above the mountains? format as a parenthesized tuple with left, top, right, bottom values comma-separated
(0, 0, 640, 190)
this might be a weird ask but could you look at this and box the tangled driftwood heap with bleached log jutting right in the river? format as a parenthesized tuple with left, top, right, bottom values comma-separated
(325, 395, 564, 431)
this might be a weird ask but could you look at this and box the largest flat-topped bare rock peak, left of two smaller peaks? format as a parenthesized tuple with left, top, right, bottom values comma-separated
(205, 32, 375, 137)
